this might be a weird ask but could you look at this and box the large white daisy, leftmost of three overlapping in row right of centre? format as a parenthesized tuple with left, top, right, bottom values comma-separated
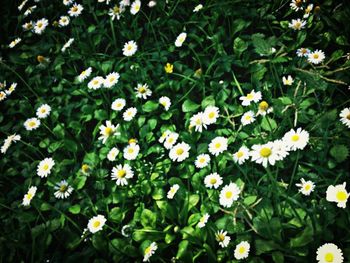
(250, 142, 278, 167)
